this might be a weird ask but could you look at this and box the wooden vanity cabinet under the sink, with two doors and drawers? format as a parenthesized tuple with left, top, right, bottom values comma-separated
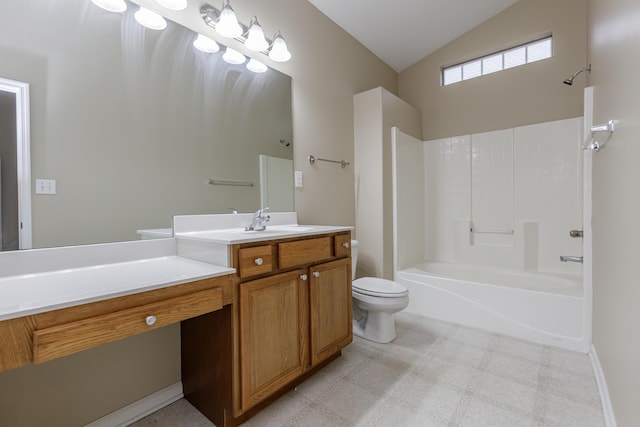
(181, 232, 352, 426)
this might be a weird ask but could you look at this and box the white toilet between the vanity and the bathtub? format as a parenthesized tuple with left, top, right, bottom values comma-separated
(351, 240, 409, 343)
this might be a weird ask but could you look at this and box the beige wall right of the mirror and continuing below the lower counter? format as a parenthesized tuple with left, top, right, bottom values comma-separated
(0, 0, 397, 426)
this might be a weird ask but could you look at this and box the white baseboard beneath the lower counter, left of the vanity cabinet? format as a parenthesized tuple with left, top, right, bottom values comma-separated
(85, 381, 184, 427)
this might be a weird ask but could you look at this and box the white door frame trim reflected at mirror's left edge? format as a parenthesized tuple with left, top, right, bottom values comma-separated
(0, 77, 32, 249)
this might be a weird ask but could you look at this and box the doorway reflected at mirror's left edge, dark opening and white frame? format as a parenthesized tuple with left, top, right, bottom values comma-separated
(0, 78, 32, 251)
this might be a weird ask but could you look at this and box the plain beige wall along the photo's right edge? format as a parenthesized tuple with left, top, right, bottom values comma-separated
(588, 0, 640, 427)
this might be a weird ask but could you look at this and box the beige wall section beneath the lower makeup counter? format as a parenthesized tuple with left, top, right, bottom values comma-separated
(0, 324, 180, 427)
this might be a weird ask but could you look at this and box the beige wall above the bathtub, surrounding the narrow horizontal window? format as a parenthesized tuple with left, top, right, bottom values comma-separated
(399, 0, 587, 140)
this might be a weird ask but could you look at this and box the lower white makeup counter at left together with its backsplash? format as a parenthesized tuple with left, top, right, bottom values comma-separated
(0, 239, 235, 320)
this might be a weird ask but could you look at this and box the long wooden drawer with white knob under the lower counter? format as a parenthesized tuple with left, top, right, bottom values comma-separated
(33, 288, 223, 363)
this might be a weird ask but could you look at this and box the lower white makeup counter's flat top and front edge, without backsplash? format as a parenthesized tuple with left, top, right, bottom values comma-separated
(0, 256, 235, 321)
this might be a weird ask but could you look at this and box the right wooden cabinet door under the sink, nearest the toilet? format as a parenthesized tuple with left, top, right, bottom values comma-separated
(309, 258, 353, 366)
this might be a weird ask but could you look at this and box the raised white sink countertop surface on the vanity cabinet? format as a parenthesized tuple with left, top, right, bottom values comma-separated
(175, 224, 353, 245)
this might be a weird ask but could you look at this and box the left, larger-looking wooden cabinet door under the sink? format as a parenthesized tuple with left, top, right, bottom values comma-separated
(239, 270, 309, 411)
